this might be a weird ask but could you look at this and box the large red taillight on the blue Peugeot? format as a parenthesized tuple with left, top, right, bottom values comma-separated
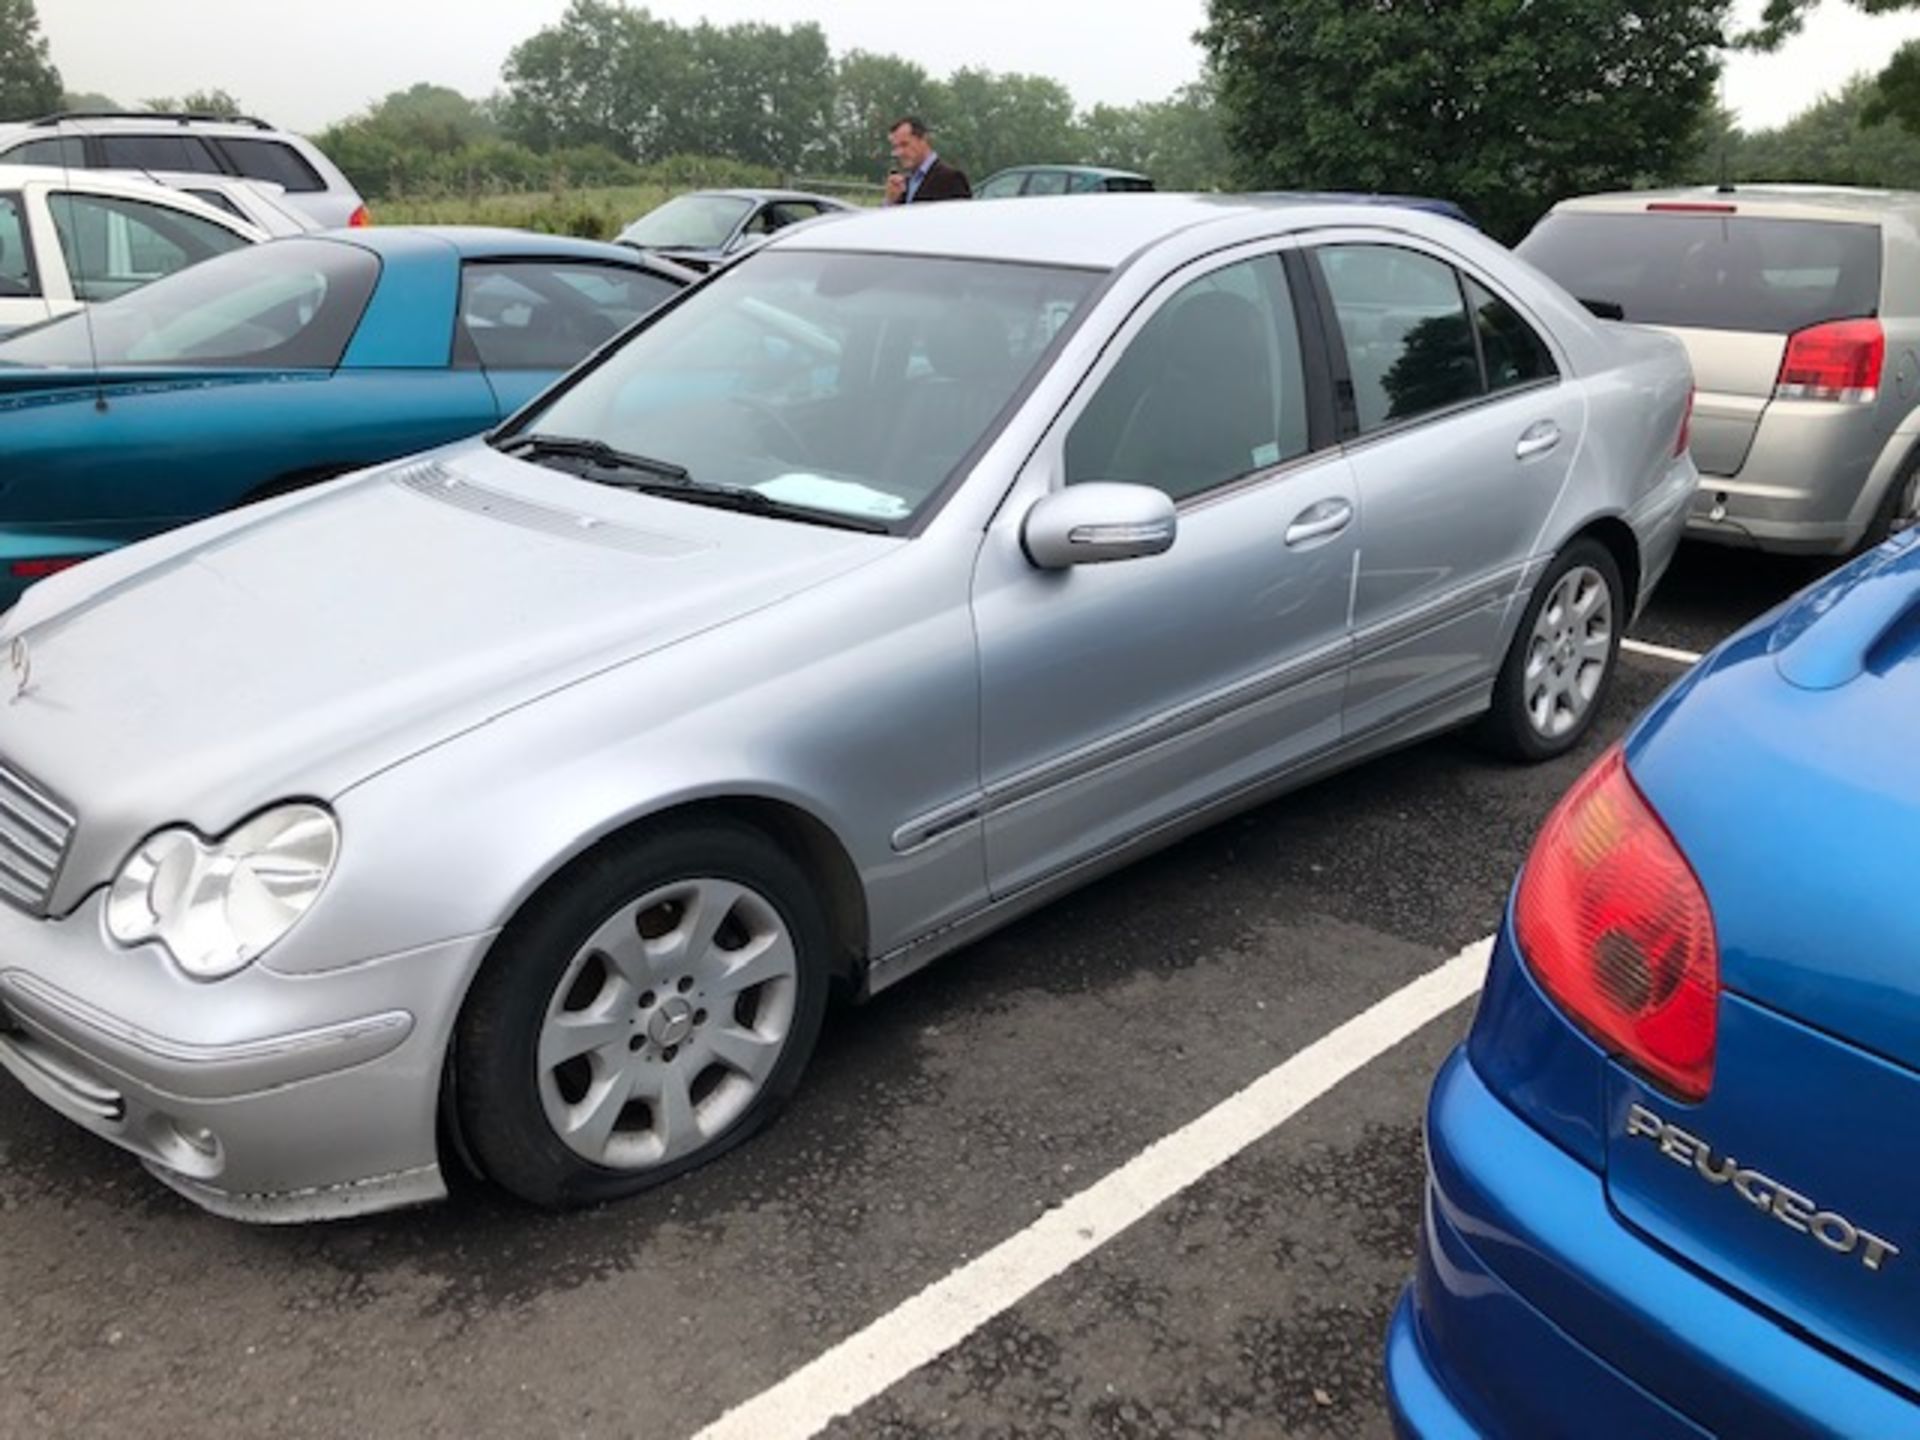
(1513, 747, 1720, 1100)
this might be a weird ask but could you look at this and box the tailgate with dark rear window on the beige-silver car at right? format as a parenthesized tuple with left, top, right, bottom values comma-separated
(1519, 202, 1882, 478)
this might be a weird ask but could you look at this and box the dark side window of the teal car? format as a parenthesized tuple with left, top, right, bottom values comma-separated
(461, 261, 676, 371)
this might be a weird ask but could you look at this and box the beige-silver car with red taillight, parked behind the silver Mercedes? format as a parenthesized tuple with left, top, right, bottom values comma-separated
(1519, 184, 1920, 555)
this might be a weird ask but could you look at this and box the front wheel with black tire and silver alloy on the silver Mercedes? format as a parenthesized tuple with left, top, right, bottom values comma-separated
(460, 822, 831, 1210)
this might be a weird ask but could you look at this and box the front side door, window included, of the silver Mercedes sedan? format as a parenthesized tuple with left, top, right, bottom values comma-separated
(973, 246, 1357, 895)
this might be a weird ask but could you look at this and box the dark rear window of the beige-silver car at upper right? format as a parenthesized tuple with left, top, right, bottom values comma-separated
(1519, 213, 1880, 334)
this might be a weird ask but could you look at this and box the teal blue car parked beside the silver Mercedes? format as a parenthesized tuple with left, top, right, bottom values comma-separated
(0, 227, 693, 611)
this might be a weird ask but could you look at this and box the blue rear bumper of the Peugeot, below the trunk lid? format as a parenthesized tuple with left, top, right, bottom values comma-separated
(1386, 1052, 1920, 1440)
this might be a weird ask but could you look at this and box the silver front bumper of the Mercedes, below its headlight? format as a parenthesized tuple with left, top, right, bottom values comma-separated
(0, 895, 492, 1223)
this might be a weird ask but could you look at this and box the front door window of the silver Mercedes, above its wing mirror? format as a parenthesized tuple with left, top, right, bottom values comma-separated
(1066, 255, 1308, 499)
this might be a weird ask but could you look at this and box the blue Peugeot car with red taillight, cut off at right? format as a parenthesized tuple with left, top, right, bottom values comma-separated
(1386, 532, 1920, 1440)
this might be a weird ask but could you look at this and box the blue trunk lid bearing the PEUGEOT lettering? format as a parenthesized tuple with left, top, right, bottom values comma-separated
(1607, 536, 1920, 1392)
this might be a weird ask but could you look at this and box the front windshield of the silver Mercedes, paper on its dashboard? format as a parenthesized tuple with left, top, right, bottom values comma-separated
(511, 252, 1100, 524)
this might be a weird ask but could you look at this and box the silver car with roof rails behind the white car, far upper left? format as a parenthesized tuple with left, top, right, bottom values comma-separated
(0, 111, 369, 228)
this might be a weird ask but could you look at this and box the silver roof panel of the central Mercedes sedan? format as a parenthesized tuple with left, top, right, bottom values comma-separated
(760, 190, 1465, 271)
